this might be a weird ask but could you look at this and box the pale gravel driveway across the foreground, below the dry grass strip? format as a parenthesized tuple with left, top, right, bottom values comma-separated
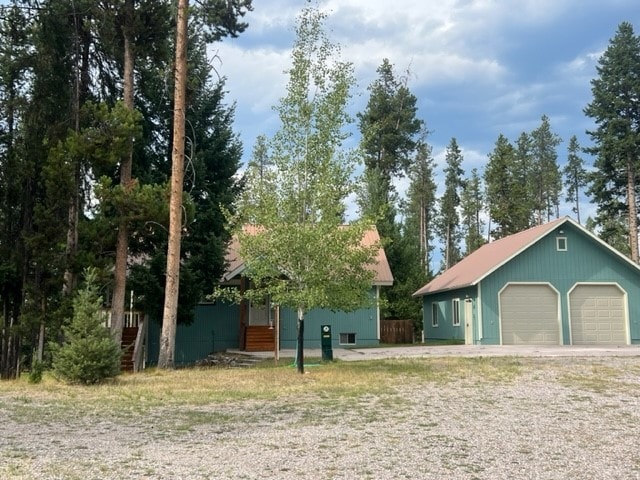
(0, 356, 640, 480)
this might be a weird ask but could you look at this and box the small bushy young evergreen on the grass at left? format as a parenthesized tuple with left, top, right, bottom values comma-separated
(52, 269, 121, 385)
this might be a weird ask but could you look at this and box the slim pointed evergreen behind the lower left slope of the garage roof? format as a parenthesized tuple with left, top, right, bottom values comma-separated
(438, 138, 464, 270)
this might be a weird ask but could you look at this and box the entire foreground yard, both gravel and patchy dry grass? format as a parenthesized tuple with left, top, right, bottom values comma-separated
(0, 357, 640, 480)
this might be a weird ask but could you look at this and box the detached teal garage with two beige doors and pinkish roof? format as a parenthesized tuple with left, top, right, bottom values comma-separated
(414, 217, 640, 345)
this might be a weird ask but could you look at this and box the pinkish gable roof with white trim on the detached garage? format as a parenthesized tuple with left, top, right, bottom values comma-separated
(413, 217, 640, 297)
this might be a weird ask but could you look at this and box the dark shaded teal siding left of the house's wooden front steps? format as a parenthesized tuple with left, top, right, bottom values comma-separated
(147, 302, 240, 365)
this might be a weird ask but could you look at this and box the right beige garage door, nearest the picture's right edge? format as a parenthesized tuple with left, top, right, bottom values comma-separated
(569, 285, 627, 345)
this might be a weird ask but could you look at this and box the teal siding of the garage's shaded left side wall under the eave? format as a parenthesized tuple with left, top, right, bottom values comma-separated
(423, 287, 477, 343)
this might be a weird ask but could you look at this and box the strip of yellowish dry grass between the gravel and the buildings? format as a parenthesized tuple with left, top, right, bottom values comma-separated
(0, 357, 640, 422)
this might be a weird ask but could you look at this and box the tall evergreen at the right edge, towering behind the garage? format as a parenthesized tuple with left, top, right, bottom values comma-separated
(585, 22, 640, 262)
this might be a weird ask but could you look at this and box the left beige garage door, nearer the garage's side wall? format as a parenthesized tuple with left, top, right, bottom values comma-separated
(500, 285, 560, 345)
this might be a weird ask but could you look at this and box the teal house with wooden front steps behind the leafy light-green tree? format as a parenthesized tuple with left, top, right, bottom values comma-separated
(147, 227, 393, 365)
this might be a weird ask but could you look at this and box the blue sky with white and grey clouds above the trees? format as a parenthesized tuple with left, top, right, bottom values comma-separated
(212, 0, 640, 215)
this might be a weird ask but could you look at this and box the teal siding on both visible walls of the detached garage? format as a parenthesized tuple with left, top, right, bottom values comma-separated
(423, 223, 640, 345)
